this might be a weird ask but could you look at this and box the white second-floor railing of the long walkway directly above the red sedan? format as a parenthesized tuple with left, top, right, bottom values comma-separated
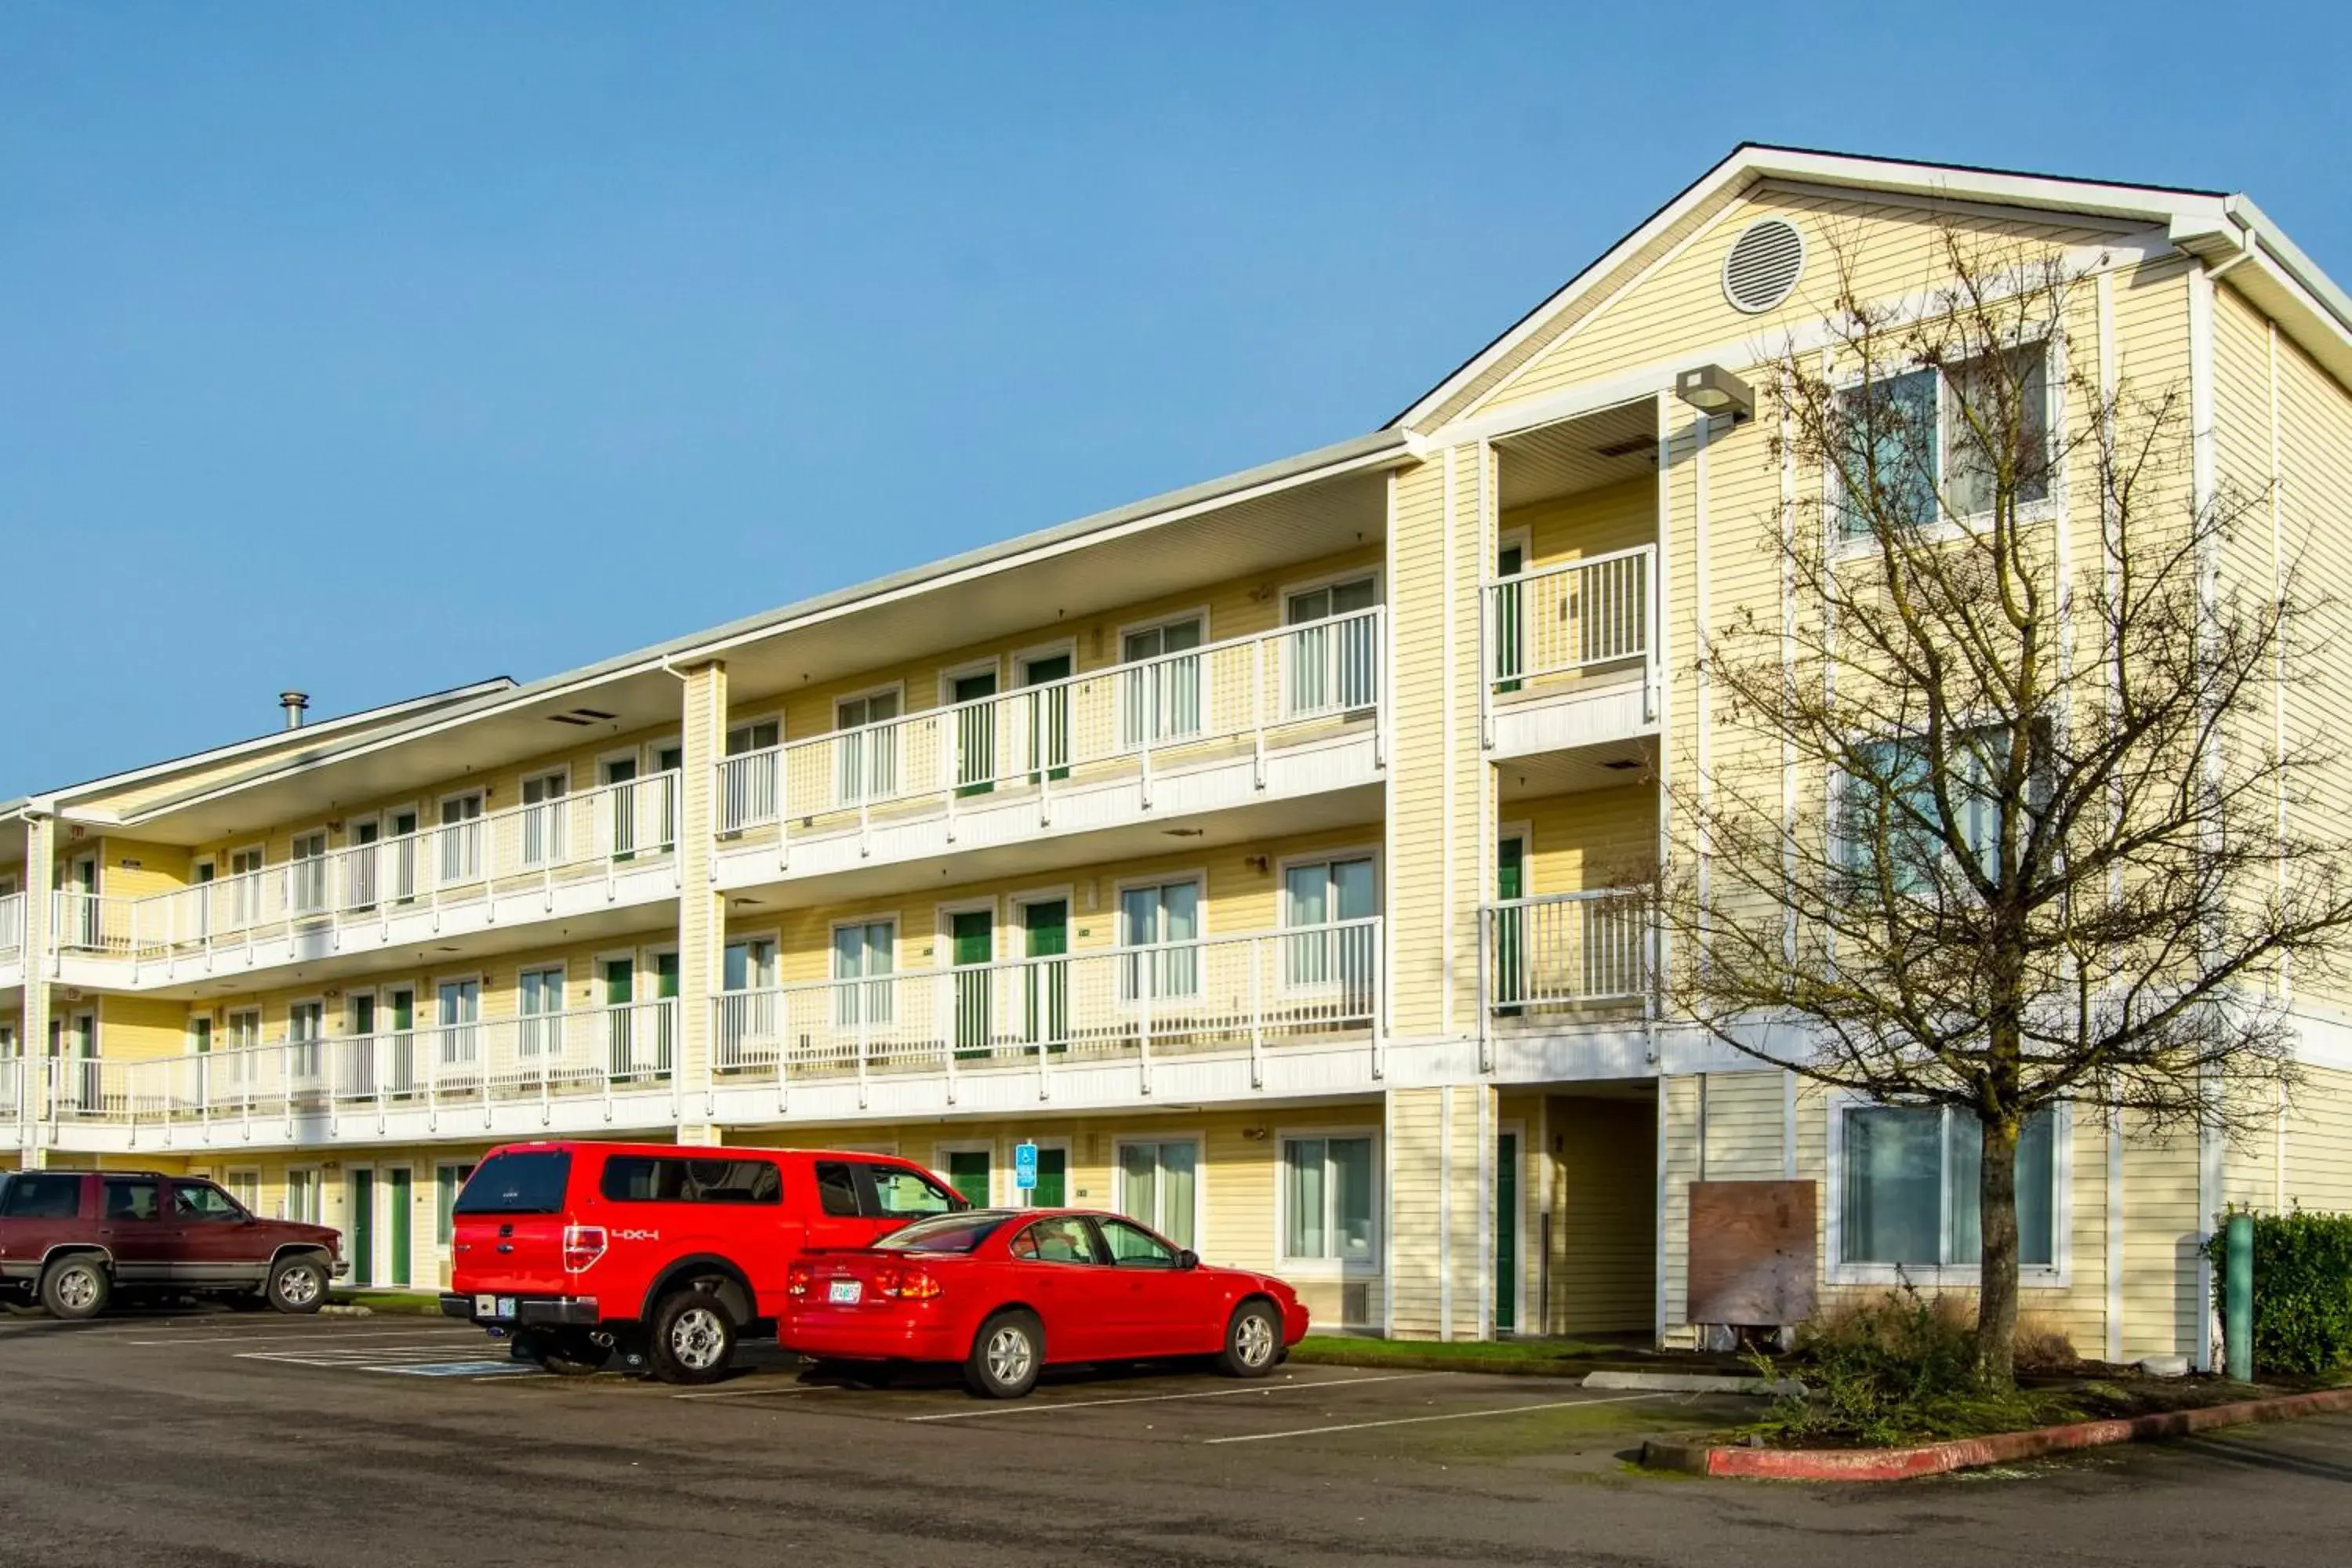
(713, 919, 1381, 1083)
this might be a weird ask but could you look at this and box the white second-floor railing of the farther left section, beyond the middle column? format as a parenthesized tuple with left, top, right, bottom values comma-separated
(47, 1001, 677, 1126)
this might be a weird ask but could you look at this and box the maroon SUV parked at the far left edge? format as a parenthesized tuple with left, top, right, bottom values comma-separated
(0, 1171, 346, 1316)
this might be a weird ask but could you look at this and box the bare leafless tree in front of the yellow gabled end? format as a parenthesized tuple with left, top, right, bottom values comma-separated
(1661, 230, 2352, 1382)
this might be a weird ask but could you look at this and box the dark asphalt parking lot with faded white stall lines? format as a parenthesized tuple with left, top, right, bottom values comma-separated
(0, 1314, 2352, 1568)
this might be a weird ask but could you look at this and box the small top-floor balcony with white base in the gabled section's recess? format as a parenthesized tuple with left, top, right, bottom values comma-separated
(1479, 546, 1658, 760)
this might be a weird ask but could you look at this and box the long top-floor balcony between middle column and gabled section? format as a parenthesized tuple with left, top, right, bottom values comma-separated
(717, 609, 1385, 888)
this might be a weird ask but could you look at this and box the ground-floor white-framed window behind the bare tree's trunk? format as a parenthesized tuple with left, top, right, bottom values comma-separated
(1830, 1098, 2067, 1283)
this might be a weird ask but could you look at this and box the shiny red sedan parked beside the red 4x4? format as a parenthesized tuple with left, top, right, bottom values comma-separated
(776, 1208, 1308, 1399)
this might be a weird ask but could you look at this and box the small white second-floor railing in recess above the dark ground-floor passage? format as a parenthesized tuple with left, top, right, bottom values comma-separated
(1479, 888, 1651, 1018)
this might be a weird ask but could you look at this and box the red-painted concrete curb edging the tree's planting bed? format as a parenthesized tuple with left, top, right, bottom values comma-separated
(1642, 1389, 2352, 1481)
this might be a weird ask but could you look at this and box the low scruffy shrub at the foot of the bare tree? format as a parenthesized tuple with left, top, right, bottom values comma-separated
(1755, 1283, 2072, 1443)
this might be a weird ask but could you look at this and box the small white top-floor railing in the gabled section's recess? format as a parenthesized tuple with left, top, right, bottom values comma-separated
(1482, 546, 1658, 699)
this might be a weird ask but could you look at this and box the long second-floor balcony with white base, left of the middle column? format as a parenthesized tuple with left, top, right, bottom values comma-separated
(38, 1001, 677, 1149)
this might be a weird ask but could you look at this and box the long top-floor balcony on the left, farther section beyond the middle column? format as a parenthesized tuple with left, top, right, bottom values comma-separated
(52, 774, 680, 985)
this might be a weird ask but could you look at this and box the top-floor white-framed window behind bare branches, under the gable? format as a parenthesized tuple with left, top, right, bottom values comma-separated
(1832, 343, 2053, 543)
